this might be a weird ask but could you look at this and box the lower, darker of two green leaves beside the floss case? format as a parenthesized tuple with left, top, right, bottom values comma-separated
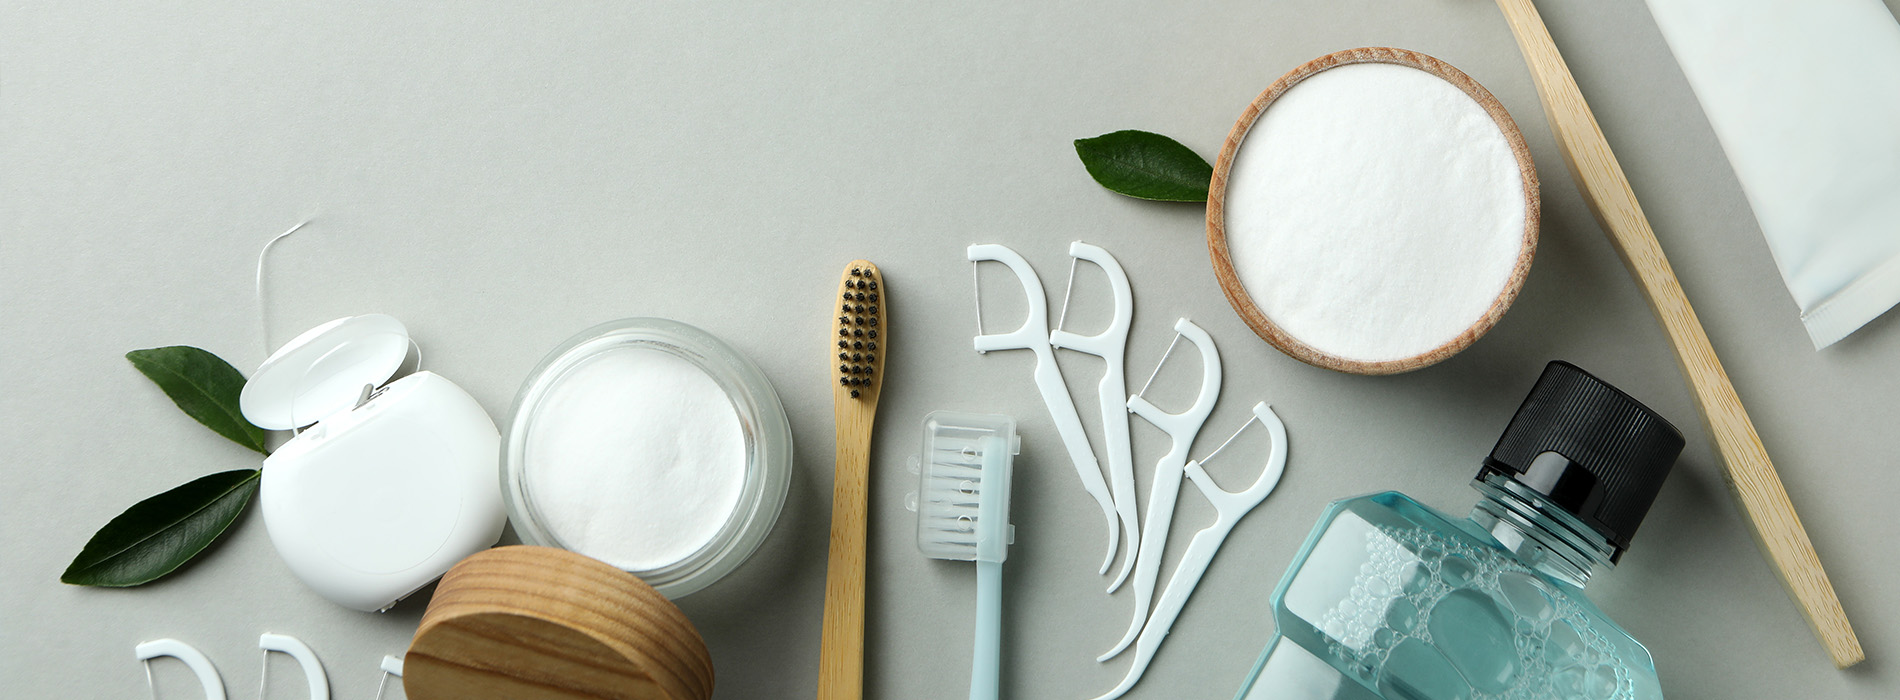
(59, 470, 262, 588)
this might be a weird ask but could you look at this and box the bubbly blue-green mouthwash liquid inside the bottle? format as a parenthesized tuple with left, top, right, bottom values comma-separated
(1319, 525, 1634, 700)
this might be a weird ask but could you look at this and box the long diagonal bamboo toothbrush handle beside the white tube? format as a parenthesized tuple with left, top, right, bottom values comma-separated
(1497, 0, 1866, 668)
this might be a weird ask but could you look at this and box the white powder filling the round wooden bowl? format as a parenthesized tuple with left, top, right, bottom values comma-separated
(1226, 63, 1524, 361)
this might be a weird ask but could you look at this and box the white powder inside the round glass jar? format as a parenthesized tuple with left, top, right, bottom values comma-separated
(524, 348, 747, 571)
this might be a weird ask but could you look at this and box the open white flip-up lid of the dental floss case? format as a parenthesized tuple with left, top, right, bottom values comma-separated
(238, 314, 409, 430)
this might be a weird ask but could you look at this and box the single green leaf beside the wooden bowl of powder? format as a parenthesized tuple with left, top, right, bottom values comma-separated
(1075, 131, 1214, 202)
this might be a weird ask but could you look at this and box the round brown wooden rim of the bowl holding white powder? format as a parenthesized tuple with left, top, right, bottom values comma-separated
(1207, 48, 1539, 375)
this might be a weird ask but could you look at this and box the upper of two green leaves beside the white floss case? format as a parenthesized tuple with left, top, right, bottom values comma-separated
(125, 344, 270, 455)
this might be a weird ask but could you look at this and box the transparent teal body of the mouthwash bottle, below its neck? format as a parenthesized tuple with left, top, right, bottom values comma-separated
(1273, 493, 1659, 698)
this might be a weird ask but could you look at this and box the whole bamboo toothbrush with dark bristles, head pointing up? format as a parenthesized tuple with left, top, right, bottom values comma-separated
(819, 261, 889, 700)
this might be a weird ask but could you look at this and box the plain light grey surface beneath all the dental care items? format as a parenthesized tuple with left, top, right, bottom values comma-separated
(0, 0, 1900, 700)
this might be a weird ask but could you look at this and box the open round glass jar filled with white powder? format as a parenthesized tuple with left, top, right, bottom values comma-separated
(502, 318, 792, 597)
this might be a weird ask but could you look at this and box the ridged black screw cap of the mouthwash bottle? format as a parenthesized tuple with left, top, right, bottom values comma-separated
(1478, 360, 1682, 557)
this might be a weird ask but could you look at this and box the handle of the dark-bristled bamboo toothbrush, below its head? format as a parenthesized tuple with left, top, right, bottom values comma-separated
(819, 399, 878, 700)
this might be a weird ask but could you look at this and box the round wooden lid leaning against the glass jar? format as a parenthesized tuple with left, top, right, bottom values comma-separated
(403, 546, 713, 700)
